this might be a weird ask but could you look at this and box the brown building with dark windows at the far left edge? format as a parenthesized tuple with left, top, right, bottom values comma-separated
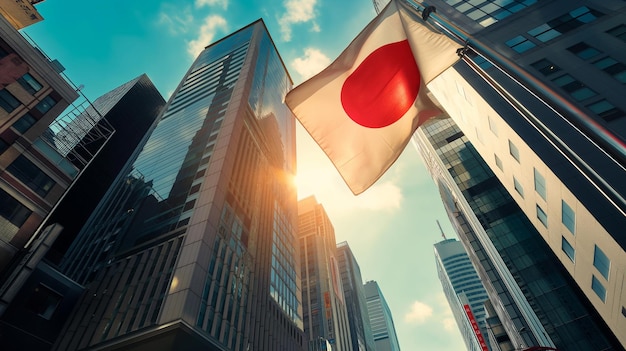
(0, 8, 79, 274)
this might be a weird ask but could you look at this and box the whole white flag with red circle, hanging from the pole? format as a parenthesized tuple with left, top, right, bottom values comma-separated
(285, 0, 459, 195)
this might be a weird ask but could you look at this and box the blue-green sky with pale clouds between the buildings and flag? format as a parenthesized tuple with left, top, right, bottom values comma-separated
(22, 0, 465, 351)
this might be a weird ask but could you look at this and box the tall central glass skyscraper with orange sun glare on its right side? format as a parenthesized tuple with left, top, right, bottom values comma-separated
(55, 20, 304, 351)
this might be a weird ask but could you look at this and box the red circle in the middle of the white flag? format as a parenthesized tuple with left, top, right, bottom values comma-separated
(341, 40, 420, 128)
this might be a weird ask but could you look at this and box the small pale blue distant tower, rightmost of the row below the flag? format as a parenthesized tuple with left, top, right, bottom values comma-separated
(364, 281, 400, 351)
